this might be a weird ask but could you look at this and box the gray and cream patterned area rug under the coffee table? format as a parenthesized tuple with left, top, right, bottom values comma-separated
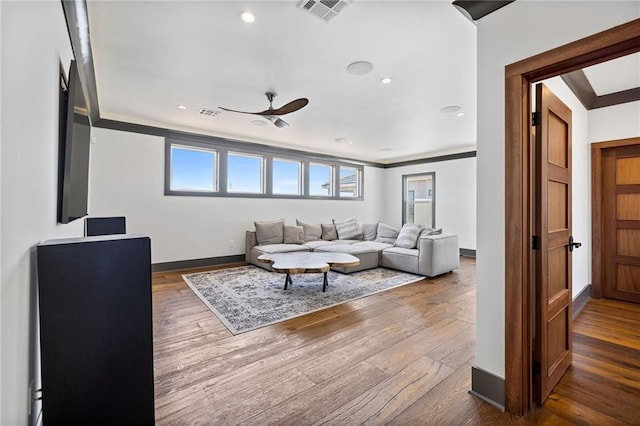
(182, 265, 424, 334)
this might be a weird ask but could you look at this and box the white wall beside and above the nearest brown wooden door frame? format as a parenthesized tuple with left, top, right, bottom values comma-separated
(476, 0, 640, 377)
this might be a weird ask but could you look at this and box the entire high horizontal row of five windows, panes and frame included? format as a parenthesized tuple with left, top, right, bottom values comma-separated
(164, 136, 364, 200)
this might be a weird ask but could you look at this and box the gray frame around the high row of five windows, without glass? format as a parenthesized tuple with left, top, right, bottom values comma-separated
(164, 137, 364, 201)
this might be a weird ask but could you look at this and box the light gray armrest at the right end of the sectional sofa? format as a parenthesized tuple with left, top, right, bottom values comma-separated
(417, 234, 460, 277)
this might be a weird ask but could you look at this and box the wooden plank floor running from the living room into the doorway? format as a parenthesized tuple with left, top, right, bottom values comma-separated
(153, 258, 640, 425)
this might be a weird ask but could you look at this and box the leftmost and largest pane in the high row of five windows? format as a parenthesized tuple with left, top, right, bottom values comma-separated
(170, 145, 218, 192)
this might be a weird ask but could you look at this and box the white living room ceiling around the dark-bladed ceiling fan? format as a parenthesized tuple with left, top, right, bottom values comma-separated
(88, 0, 476, 163)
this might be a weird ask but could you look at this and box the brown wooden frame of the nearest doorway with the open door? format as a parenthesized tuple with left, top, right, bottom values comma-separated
(504, 19, 640, 416)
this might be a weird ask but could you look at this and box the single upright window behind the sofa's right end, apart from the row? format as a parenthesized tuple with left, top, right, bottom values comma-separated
(402, 172, 436, 227)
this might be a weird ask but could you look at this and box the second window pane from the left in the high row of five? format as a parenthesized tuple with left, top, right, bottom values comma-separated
(227, 152, 264, 194)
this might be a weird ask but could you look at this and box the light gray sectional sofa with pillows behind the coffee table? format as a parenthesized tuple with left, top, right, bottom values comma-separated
(245, 218, 460, 277)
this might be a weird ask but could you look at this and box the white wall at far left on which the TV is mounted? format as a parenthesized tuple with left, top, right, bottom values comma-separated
(0, 1, 82, 425)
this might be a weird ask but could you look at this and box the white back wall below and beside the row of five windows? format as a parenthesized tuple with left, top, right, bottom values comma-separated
(90, 129, 384, 263)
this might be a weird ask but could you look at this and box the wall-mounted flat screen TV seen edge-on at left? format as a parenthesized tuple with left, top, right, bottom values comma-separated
(58, 61, 91, 223)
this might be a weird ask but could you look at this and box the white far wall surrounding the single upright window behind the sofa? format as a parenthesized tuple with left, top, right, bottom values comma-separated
(381, 157, 476, 250)
